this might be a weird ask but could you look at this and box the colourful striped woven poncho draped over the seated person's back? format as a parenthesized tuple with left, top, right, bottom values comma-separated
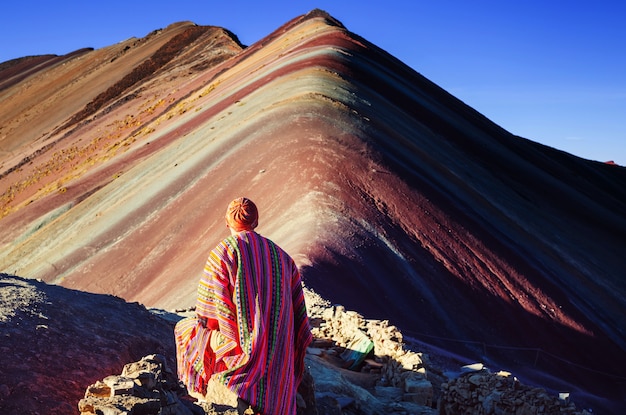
(175, 231, 312, 415)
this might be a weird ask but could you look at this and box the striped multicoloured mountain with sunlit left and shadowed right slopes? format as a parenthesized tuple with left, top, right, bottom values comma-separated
(0, 10, 626, 412)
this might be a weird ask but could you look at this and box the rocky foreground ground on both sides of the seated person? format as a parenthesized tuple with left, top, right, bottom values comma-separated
(0, 274, 586, 415)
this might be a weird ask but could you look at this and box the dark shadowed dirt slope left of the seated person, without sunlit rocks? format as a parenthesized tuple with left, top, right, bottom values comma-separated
(0, 274, 174, 415)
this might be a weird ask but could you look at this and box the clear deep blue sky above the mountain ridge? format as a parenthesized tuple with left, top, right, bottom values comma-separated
(0, 0, 626, 166)
